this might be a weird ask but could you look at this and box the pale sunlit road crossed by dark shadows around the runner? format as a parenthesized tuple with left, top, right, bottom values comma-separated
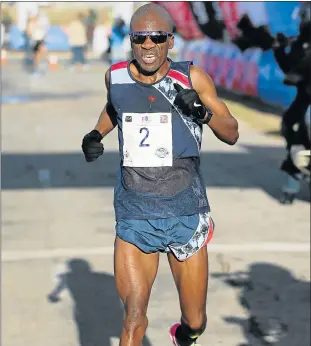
(1, 60, 310, 346)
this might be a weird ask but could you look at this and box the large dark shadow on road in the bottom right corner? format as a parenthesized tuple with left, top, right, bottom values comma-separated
(212, 263, 310, 346)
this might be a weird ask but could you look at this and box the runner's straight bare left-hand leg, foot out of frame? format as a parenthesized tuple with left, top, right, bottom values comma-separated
(114, 237, 159, 346)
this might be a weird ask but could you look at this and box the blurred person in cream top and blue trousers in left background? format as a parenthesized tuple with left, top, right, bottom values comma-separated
(67, 13, 87, 69)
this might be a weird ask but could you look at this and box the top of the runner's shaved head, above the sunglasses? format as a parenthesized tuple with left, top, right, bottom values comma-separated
(130, 3, 174, 32)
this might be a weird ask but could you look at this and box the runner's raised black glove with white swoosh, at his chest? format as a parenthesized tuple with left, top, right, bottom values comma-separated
(174, 83, 211, 121)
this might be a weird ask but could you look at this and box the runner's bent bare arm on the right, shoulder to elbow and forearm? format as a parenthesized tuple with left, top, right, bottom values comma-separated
(190, 66, 239, 145)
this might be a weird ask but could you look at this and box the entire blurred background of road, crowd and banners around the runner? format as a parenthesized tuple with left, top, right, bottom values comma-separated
(1, 1, 311, 346)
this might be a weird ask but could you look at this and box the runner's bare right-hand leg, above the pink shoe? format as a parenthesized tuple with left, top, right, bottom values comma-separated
(168, 246, 208, 342)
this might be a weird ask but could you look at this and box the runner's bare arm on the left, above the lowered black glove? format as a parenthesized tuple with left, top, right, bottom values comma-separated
(94, 70, 117, 137)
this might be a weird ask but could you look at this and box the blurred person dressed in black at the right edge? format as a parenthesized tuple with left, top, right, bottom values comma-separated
(273, 21, 311, 203)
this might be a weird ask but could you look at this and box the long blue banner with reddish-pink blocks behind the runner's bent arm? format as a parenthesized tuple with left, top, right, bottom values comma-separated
(181, 39, 296, 108)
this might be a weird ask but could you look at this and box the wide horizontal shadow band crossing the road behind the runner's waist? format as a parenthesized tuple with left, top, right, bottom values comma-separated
(1, 145, 310, 201)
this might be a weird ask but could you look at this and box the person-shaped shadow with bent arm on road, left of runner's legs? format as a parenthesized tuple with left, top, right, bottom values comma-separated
(48, 258, 151, 346)
